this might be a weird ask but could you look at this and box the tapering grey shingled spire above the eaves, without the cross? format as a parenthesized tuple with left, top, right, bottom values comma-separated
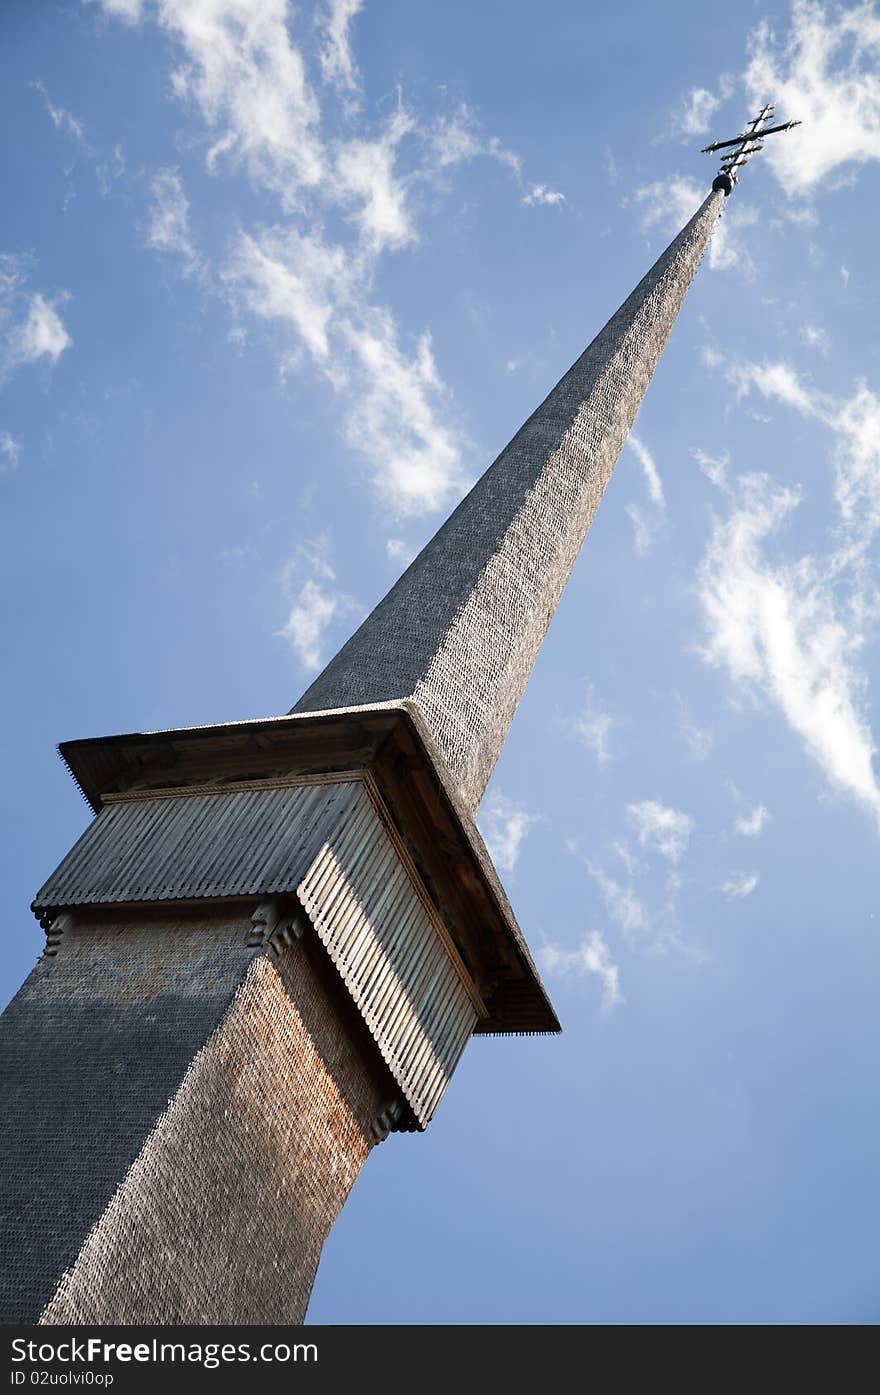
(293, 188, 725, 810)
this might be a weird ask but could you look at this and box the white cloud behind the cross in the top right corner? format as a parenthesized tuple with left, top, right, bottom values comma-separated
(745, 0, 880, 195)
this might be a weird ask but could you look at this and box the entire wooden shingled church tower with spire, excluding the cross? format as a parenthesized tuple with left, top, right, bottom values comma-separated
(0, 191, 724, 1322)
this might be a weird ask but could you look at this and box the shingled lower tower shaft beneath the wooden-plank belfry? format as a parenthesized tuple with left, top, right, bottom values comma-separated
(0, 907, 390, 1324)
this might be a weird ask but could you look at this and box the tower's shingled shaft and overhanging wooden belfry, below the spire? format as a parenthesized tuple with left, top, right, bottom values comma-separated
(0, 704, 558, 1324)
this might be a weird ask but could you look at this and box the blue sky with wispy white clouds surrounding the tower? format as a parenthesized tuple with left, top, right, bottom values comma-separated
(0, 0, 880, 1322)
